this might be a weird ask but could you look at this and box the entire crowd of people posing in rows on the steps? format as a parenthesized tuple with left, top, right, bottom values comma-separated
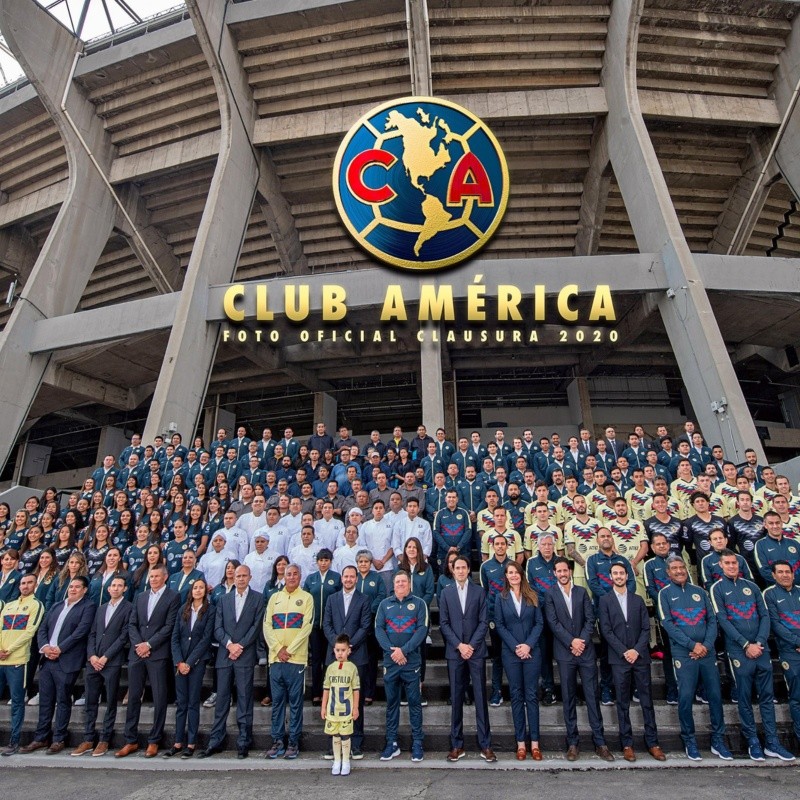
(0, 422, 800, 775)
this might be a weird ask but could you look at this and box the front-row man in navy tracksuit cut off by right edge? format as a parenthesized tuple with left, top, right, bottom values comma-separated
(764, 561, 800, 752)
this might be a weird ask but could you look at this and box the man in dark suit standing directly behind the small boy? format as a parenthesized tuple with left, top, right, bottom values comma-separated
(322, 567, 372, 760)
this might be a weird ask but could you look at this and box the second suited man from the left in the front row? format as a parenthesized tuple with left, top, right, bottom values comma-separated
(72, 574, 133, 756)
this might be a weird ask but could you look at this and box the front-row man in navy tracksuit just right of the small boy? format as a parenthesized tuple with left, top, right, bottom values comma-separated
(376, 571, 428, 762)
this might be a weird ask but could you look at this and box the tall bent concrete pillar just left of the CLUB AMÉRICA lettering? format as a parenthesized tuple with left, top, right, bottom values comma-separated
(144, 0, 258, 442)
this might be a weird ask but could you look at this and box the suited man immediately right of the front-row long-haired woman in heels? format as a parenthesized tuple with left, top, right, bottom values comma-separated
(544, 557, 614, 761)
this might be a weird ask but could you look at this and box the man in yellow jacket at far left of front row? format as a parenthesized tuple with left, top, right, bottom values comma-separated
(0, 575, 44, 756)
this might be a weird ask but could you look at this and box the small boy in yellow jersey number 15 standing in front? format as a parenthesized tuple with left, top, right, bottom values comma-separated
(320, 633, 361, 775)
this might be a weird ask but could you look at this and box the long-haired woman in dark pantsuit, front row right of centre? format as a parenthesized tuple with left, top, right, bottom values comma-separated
(494, 561, 544, 761)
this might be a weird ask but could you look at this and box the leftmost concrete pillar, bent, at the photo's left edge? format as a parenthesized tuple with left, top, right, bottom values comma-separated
(0, 0, 115, 472)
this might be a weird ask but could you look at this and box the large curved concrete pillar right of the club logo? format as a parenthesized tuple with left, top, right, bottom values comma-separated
(602, 0, 764, 463)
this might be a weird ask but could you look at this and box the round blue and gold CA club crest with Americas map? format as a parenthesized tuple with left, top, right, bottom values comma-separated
(333, 97, 509, 270)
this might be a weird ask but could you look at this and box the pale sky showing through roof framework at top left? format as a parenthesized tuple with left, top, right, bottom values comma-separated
(0, 0, 183, 86)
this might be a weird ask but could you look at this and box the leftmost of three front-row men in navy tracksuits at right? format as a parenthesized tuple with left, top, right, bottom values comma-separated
(658, 555, 733, 761)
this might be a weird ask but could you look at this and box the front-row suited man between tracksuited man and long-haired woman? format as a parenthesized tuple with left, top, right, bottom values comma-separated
(439, 556, 497, 764)
